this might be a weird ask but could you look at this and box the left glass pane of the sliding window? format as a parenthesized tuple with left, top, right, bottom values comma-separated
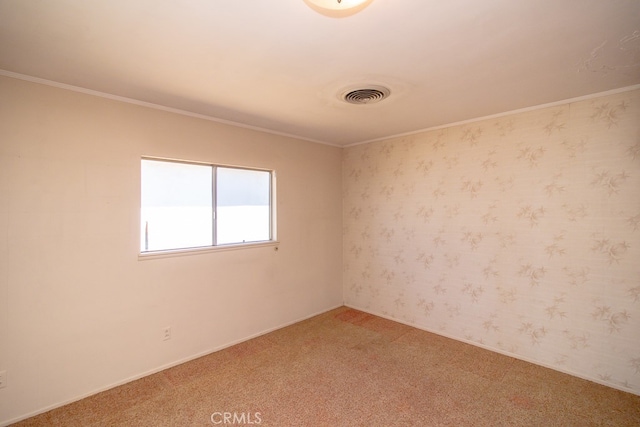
(140, 159, 213, 252)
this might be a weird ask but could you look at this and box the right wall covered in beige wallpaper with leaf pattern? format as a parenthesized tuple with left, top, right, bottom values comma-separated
(343, 90, 640, 394)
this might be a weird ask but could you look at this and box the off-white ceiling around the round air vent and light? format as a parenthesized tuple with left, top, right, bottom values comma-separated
(0, 0, 640, 146)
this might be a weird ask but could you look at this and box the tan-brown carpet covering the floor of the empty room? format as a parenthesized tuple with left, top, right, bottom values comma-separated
(11, 307, 640, 427)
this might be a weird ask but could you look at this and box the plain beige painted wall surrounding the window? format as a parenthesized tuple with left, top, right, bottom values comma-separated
(0, 77, 342, 424)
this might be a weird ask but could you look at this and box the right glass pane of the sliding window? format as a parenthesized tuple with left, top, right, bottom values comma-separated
(216, 167, 271, 245)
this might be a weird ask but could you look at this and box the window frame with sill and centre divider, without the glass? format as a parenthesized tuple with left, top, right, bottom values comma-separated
(138, 156, 279, 259)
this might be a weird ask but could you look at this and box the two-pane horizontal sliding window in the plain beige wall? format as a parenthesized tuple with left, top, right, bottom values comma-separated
(140, 159, 274, 252)
